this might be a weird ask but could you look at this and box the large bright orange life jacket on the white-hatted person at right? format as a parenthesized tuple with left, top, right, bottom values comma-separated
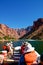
(24, 51, 37, 65)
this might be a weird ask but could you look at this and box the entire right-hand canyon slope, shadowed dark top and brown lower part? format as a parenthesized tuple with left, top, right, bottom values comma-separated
(20, 18, 43, 39)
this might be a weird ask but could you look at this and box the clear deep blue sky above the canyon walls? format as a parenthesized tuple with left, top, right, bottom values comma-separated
(0, 0, 43, 28)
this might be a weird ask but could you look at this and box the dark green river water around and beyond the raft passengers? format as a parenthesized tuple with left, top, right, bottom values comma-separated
(0, 40, 43, 54)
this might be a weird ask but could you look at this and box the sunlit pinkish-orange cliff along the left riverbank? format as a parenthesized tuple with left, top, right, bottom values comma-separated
(0, 24, 19, 38)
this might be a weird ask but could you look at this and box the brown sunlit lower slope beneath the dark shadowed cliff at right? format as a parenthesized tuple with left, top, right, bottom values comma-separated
(27, 25, 43, 39)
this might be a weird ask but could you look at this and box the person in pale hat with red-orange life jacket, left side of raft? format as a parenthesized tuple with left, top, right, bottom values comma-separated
(3, 42, 13, 58)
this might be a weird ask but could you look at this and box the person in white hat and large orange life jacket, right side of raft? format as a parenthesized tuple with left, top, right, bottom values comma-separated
(18, 42, 40, 65)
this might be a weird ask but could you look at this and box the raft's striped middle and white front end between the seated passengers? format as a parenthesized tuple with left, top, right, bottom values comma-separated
(0, 46, 21, 65)
